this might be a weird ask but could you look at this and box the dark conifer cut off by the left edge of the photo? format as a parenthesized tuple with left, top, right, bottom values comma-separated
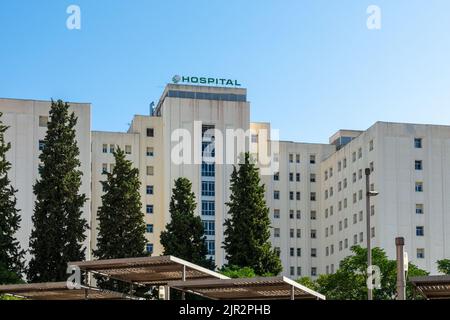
(0, 112, 24, 284)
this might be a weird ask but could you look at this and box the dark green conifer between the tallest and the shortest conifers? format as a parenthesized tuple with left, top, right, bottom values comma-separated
(94, 148, 147, 290)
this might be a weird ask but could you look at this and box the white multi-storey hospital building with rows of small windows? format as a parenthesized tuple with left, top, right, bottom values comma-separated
(0, 84, 450, 278)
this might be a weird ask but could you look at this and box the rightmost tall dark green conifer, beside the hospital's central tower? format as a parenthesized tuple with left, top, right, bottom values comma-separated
(223, 153, 282, 275)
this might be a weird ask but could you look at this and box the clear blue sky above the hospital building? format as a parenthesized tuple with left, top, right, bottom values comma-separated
(0, 0, 450, 142)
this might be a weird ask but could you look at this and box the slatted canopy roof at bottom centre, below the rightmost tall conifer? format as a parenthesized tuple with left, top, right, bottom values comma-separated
(169, 277, 325, 300)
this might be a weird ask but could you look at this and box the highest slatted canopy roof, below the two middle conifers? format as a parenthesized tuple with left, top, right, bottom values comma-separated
(68, 256, 229, 286)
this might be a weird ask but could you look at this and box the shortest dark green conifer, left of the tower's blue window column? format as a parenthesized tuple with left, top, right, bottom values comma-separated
(161, 178, 215, 269)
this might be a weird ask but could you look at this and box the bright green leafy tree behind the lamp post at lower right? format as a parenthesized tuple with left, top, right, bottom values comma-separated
(302, 246, 427, 300)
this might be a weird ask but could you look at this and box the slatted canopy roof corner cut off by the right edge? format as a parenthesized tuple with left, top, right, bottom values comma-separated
(409, 276, 450, 300)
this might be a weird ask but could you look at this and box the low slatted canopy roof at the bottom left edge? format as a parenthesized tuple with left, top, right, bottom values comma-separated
(0, 282, 137, 300)
